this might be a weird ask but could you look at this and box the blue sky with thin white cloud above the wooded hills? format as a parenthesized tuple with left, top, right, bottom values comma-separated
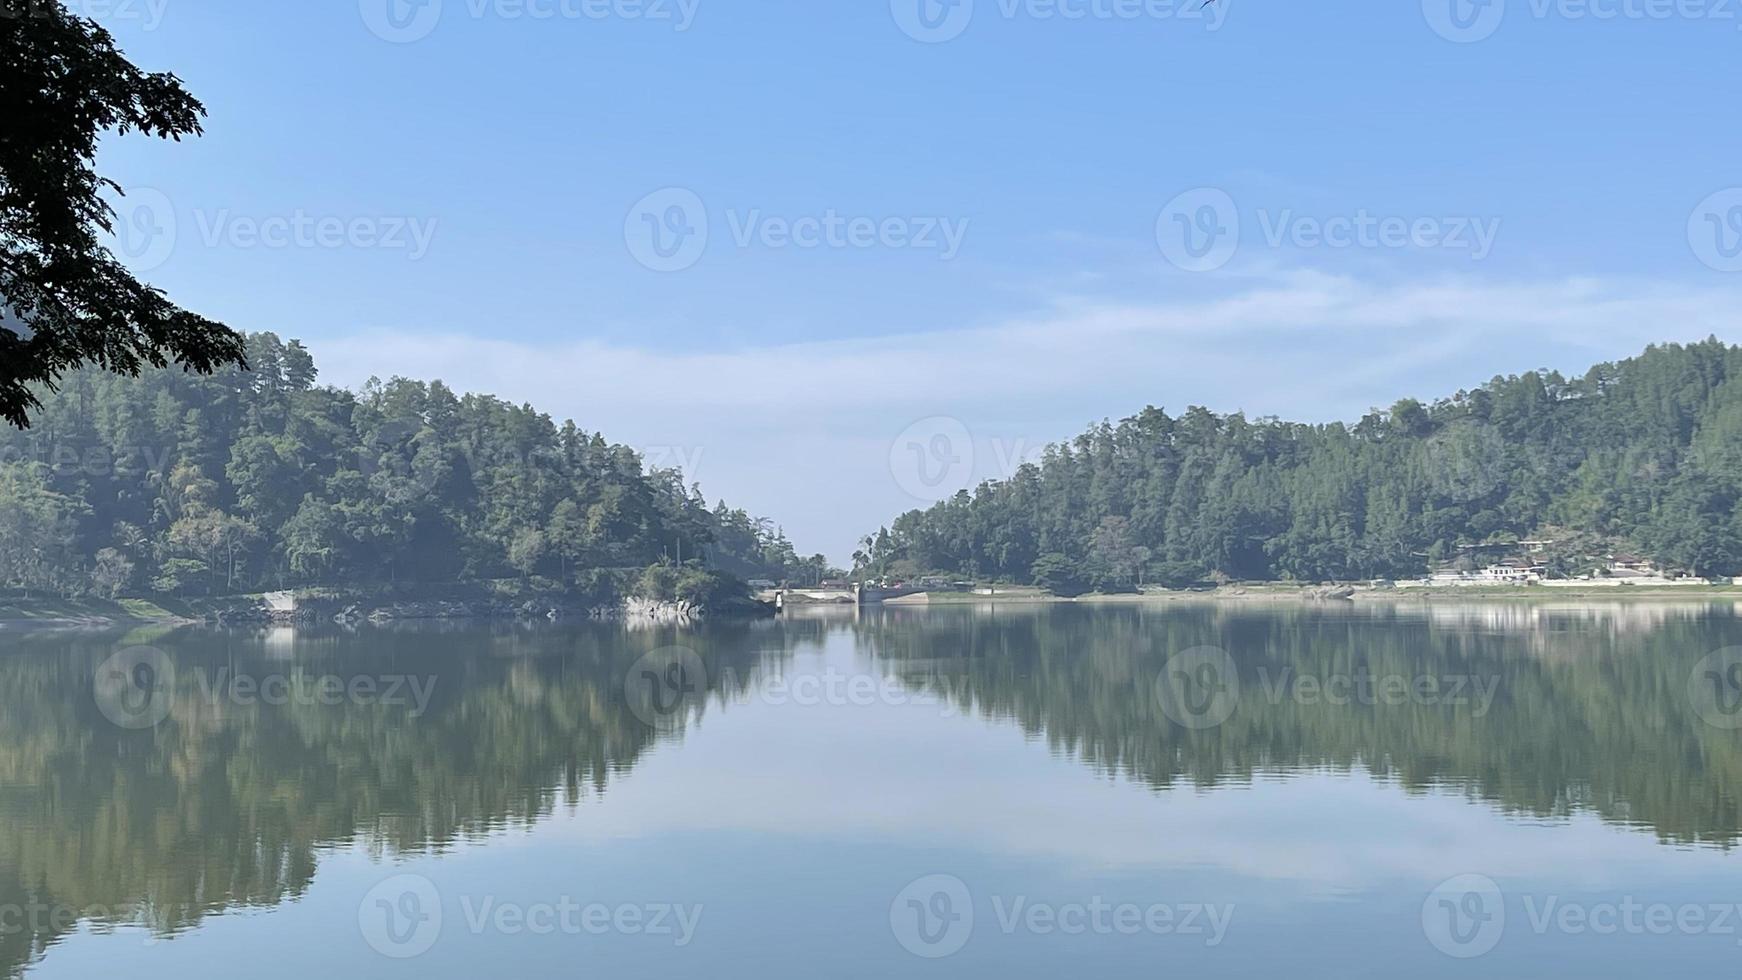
(91, 0, 1742, 559)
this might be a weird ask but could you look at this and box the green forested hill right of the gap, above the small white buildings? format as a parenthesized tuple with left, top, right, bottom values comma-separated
(857, 339, 1742, 588)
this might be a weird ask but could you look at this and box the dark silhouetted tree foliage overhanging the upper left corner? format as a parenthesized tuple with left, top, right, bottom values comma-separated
(0, 0, 242, 428)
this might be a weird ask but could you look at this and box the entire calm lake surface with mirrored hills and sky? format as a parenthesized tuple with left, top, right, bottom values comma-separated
(0, 602, 1742, 980)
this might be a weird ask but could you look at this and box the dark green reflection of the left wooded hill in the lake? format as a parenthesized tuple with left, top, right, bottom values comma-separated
(0, 623, 820, 973)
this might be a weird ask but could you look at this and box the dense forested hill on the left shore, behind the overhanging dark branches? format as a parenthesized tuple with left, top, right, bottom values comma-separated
(0, 334, 826, 597)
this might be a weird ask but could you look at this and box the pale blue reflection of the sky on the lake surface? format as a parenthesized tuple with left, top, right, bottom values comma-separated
(23, 619, 1742, 978)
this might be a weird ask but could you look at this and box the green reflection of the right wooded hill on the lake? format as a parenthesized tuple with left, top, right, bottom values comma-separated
(852, 604, 1742, 848)
